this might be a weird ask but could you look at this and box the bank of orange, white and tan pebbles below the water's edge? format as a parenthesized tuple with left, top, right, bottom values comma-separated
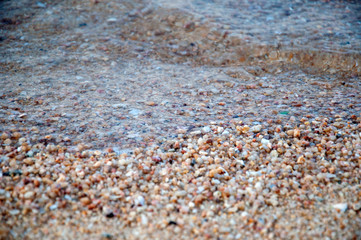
(0, 115, 361, 239)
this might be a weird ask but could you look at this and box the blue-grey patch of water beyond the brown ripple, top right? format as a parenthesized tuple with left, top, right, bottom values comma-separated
(153, 0, 361, 53)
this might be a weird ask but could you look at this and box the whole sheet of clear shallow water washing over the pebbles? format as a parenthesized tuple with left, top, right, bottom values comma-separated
(0, 0, 361, 152)
